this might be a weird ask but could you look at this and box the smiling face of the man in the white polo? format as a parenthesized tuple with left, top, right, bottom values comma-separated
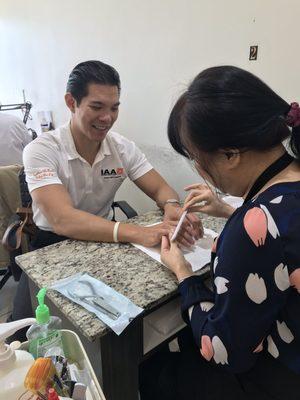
(72, 83, 120, 142)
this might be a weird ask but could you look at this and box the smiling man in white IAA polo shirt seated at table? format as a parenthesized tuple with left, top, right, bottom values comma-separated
(11, 61, 201, 339)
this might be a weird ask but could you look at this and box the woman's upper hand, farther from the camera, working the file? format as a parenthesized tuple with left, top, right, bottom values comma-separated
(183, 183, 235, 218)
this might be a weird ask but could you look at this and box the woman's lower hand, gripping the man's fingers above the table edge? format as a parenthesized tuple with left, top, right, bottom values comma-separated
(160, 236, 194, 280)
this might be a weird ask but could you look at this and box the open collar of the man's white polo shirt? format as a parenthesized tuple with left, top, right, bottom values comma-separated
(61, 122, 111, 164)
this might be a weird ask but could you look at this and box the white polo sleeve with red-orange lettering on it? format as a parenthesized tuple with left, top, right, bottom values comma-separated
(23, 138, 62, 193)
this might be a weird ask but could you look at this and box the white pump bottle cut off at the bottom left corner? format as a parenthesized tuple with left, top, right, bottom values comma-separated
(0, 318, 35, 400)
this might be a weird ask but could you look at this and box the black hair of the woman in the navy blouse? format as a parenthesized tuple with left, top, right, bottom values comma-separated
(168, 66, 300, 157)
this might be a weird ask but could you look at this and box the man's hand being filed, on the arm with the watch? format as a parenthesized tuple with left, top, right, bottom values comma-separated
(164, 203, 203, 247)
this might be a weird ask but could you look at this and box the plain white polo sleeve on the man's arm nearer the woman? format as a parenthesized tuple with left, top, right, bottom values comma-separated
(116, 135, 153, 181)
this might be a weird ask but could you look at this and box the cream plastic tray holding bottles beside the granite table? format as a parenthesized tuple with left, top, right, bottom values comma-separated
(21, 329, 105, 400)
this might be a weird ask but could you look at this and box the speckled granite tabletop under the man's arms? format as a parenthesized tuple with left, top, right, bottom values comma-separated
(16, 211, 225, 341)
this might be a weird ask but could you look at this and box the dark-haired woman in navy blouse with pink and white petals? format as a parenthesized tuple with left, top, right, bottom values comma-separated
(147, 66, 300, 400)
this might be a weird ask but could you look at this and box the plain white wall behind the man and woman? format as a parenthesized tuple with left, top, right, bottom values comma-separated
(0, 0, 300, 211)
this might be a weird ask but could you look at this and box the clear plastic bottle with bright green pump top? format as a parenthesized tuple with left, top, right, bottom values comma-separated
(26, 288, 64, 358)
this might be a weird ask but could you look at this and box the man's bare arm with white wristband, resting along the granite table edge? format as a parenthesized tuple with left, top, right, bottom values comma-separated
(31, 184, 171, 246)
